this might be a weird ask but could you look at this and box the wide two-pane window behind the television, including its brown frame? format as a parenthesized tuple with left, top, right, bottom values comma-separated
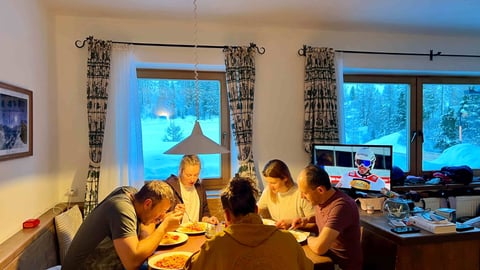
(339, 75, 480, 175)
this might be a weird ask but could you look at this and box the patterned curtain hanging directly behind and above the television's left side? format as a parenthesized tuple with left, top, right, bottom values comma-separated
(303, 47, 338, 153)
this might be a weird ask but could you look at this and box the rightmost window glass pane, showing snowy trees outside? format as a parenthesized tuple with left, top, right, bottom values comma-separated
(422, 83, 480, 171)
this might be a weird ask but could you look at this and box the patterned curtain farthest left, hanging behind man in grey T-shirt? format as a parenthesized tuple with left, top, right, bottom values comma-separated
(83, 39, 112, 217)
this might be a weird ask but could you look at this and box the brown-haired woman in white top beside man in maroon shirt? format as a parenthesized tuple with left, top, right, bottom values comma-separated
(257, 159, 314, 229)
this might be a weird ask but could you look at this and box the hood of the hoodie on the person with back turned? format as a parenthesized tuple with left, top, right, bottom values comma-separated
(224, 214, 278, 247)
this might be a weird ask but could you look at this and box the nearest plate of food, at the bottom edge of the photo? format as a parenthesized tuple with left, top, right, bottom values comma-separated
(148, 251, 193, 270)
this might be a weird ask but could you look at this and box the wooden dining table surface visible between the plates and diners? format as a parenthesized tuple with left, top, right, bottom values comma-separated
(155, 234, 334, 270)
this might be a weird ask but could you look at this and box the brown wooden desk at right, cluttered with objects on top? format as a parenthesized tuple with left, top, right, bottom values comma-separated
(360, 210, 480, 270)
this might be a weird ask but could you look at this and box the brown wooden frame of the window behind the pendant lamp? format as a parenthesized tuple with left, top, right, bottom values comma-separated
(137, 68, 231, 190)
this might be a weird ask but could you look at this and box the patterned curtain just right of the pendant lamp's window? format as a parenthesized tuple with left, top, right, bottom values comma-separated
(223, 47, 257, 181)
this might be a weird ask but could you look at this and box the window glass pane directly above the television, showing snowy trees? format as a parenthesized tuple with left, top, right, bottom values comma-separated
(343, 82, 410, 171)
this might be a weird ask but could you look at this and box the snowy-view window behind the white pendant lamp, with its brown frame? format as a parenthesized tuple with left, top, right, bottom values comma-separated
(137, 69, 230, 189)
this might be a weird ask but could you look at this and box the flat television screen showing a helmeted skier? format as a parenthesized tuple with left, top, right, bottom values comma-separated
(312, 144, 393, 193)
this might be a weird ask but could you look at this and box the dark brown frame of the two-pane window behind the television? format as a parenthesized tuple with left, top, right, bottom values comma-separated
(340, 74, 480, 176)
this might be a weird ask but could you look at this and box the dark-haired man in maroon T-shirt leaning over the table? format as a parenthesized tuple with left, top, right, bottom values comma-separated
(293, 165, 363, 270)
